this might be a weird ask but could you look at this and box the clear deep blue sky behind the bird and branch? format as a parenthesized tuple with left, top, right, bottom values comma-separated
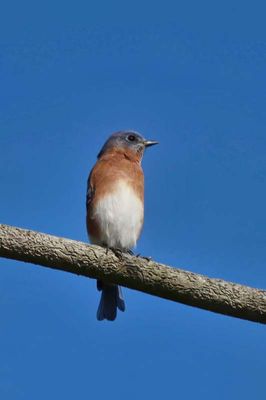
(0, 1, 266, 400)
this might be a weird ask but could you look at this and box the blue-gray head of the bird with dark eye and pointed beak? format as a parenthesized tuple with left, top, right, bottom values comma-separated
(98, 131, 158, 158)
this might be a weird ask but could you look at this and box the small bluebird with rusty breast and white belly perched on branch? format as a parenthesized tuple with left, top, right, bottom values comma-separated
(86, 130, 158, 321)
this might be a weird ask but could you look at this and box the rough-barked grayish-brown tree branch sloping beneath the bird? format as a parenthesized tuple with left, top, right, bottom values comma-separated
(0, 224, 266, 324)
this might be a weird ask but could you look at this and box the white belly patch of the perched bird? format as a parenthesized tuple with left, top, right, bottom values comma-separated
(94, 181, 143, 249)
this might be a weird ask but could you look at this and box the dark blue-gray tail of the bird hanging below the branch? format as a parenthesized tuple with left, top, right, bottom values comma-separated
(97, 281, 125, 321)
